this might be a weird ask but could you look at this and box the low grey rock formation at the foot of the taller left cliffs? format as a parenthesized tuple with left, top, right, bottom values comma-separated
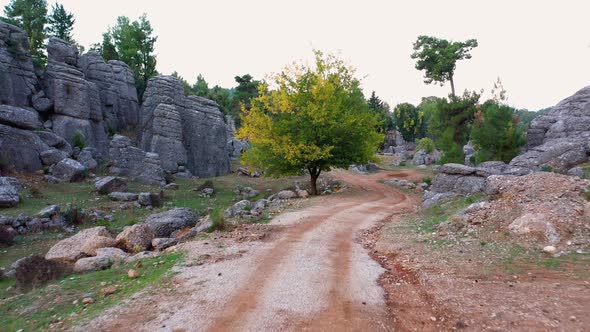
(109, 135, 166, 185)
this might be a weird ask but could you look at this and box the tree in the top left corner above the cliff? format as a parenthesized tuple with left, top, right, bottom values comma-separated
(3, 0, 47, 67)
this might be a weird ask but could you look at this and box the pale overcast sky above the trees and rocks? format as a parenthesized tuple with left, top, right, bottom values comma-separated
(0, 0, 590, 110)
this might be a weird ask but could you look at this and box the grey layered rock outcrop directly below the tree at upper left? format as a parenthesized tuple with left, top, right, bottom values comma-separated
(78, 51, 139, 130)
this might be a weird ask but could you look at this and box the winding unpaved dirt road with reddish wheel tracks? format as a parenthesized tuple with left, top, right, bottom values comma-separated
(80, 171, 415, 331)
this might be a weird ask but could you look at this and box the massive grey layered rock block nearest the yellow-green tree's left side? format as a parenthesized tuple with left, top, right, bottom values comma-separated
(140, 76, 229, 176)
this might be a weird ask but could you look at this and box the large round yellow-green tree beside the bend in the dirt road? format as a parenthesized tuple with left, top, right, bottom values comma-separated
(238, 51, 383, 195)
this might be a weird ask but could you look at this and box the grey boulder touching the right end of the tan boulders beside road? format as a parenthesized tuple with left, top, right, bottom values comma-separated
(145, 208, 199, 237)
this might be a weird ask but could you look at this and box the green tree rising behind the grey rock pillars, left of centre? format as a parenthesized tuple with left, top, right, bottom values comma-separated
(99, 14, 158, 100)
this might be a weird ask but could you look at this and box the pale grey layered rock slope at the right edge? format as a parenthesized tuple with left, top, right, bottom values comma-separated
(510, 86, 590, 172)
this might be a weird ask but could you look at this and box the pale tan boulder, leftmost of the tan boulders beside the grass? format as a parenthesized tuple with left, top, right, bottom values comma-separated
(45, 226, 111, 264)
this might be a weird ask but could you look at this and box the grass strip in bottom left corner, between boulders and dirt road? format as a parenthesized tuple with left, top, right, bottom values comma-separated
(0, 253, 182, 331)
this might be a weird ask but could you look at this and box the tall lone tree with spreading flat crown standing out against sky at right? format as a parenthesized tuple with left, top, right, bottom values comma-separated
(412, 36, 477, 96)
